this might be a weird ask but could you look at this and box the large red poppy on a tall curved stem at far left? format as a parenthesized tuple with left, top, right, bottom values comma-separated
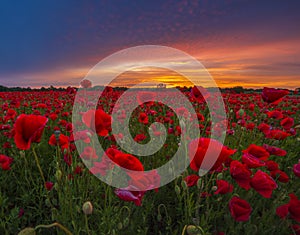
(14, 114, 48, 150)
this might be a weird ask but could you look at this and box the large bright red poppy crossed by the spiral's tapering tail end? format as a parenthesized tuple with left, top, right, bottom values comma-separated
(189, 137, 236, 171)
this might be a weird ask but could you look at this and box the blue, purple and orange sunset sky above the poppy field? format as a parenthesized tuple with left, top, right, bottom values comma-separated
(0, 0, 300, 89)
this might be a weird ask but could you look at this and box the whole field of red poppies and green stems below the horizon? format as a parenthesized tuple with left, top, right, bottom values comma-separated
(0, 87, 300, 235)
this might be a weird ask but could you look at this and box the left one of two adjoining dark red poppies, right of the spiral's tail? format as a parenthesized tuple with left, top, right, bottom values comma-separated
(230, 160, 252, 190)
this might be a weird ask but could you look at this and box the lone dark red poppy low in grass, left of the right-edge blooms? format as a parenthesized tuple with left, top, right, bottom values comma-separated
(229, 196, 252, 222)
